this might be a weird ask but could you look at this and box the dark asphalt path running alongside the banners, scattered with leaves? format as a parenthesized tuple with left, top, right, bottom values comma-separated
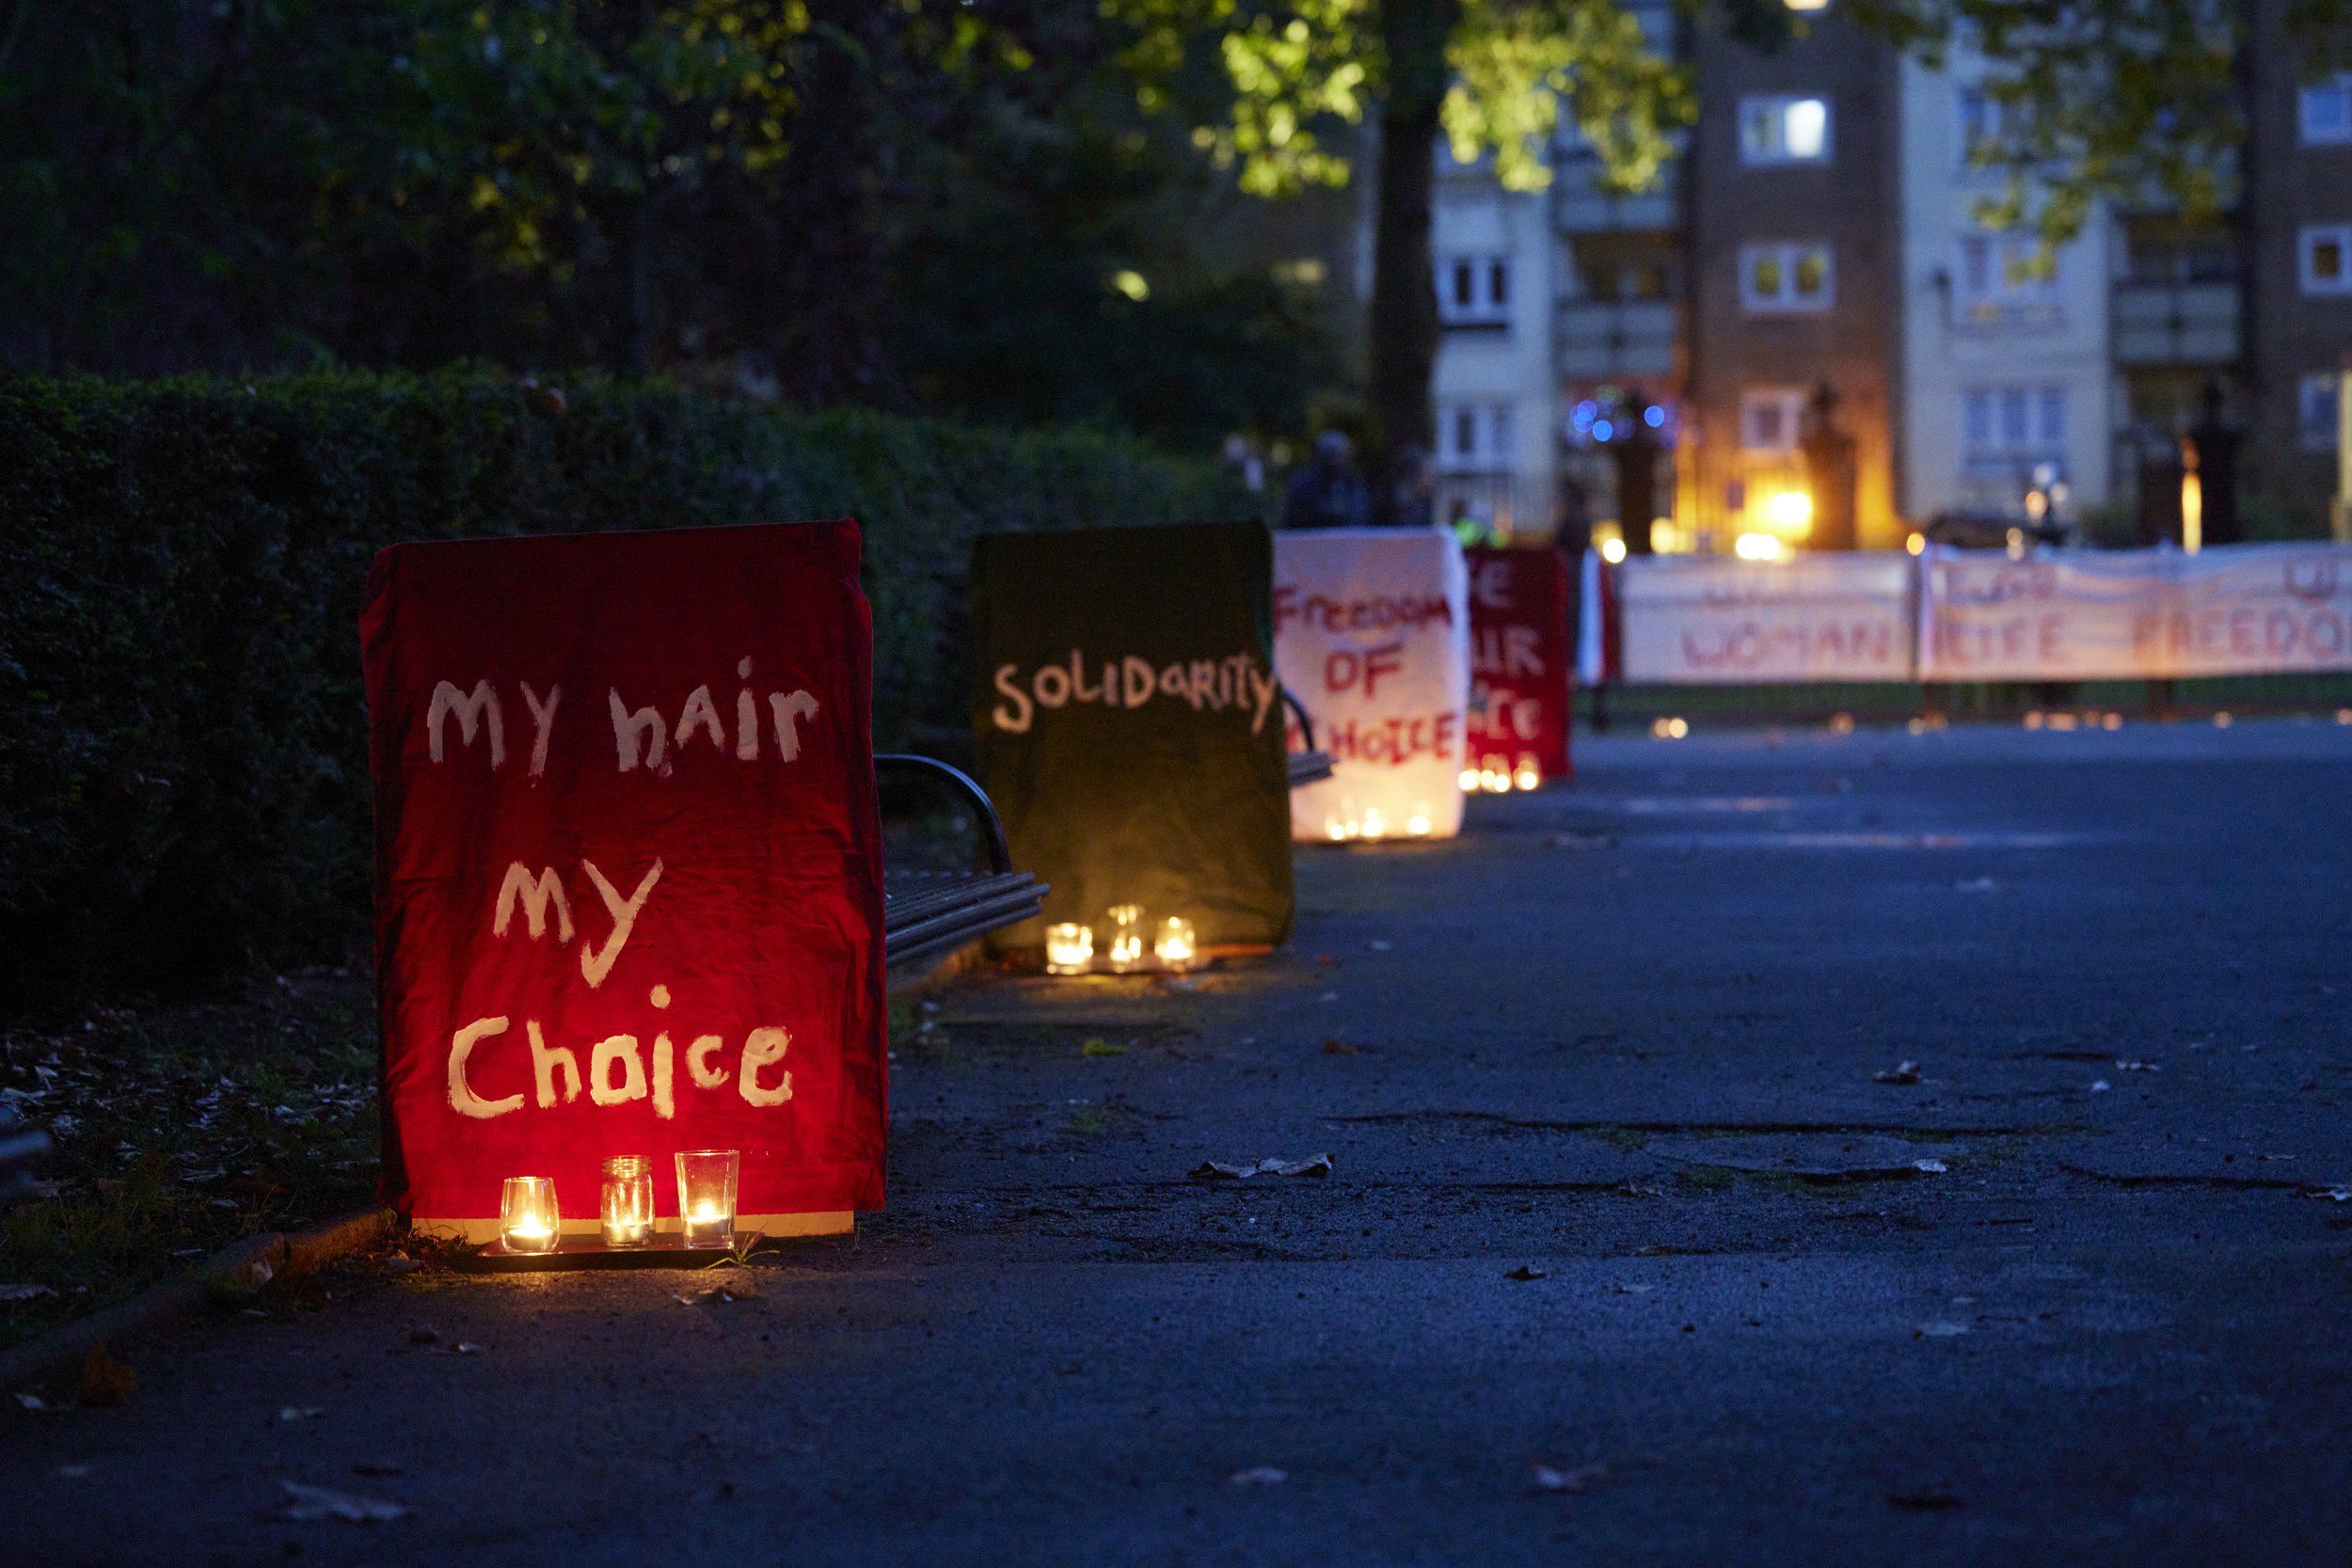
(0, 721, 2352, 1568)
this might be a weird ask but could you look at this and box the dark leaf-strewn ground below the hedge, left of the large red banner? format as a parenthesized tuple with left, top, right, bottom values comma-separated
(0, 971, 376, 1347)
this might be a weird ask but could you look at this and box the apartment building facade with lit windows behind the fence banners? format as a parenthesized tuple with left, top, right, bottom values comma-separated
(1435, 0, 2352, 552)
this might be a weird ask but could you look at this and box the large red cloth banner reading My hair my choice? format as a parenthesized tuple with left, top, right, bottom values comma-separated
(360, 522, 887, 1229)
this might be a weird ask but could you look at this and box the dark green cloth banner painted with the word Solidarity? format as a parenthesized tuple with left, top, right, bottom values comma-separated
(972, 522, 1294, 950)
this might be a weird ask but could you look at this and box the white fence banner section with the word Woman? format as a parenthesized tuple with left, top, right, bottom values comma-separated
(1616, 550, 1915, 687)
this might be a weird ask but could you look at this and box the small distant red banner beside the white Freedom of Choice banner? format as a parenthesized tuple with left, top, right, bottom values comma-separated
(1463, 547, 1571, 778)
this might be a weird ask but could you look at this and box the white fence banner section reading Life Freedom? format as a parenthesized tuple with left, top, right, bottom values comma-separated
(1919, 543, 2352, 682)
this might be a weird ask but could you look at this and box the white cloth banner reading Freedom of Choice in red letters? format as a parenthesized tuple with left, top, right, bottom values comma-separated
(1275, 529, 1470, 842)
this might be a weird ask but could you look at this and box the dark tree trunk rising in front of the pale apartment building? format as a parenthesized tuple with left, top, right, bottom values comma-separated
(1372, 0, 1461, 470)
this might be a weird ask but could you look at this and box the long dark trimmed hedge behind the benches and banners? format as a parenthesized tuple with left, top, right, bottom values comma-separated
(0, 373, 1245, 1013)
